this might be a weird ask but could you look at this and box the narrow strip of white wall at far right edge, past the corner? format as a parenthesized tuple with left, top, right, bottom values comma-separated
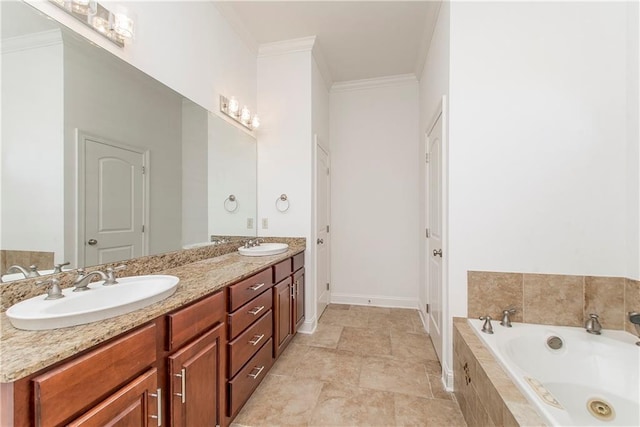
(626, 2, 640, 280)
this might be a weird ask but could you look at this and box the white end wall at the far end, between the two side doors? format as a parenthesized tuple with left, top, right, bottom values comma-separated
(330, 78, 421, 308)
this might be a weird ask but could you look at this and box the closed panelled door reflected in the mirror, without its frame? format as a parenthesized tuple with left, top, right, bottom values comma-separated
(84, 138, 145, 265)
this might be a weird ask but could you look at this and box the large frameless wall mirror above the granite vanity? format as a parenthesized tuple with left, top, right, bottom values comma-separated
(0, 1, 256, 281)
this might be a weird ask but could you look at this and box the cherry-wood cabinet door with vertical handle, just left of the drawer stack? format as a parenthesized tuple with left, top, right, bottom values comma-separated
(168, 324, 224, 427)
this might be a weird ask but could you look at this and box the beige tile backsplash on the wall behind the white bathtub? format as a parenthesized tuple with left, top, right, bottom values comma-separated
(467, 271, 640, 333)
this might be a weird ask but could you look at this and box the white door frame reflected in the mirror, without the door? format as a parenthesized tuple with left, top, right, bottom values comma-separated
(75, 128, 151, 268)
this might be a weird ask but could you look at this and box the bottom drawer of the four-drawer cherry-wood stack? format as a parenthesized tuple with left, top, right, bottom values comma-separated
(228, 339, 273, 417)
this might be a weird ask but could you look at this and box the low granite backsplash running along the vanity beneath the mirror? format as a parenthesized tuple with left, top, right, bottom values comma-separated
(0, 237, 306, 311)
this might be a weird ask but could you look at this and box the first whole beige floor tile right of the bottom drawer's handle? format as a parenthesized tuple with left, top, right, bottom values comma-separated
(293, 347, 362, 386)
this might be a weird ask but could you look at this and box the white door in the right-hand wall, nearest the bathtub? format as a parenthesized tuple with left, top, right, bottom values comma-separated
(426, 114, 444, 360)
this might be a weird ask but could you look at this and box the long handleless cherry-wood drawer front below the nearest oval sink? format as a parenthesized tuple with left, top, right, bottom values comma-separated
(33, 324, 156, 426)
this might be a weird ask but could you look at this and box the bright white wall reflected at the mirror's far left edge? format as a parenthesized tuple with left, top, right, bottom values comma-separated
(0, 30, 64, 260)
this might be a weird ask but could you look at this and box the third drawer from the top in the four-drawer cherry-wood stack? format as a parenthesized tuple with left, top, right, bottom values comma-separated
(228, 310, 273, 378)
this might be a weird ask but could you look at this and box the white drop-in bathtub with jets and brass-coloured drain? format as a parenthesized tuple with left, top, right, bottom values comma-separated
(468, 319, 640, 426)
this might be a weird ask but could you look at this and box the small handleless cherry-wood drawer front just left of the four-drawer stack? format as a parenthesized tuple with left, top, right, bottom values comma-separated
(167, 291, 225, 351)
